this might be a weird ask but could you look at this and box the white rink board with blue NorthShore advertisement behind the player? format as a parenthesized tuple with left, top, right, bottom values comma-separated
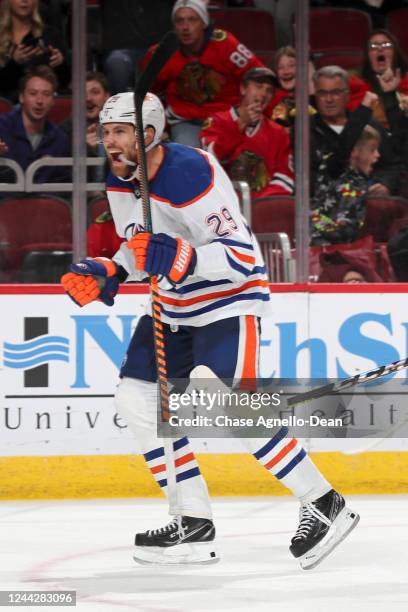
(0, 285, 408, 498)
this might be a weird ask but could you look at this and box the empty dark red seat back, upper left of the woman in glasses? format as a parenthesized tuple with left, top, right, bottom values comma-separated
(310, 8, 372, 53)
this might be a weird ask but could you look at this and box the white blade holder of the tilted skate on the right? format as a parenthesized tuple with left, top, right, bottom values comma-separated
(299, 508, 360, 570)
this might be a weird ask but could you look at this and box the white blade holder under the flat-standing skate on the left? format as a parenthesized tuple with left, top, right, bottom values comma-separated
(133, 542, 220, 565)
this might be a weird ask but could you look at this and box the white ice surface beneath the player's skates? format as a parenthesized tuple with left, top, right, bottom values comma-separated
(0, 495, 408, 612)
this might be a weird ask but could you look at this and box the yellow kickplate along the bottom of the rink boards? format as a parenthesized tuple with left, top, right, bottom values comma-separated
(0, 451, 408, 499)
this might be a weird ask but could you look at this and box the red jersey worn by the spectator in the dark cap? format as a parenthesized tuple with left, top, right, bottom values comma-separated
(201, 108, 294, 197)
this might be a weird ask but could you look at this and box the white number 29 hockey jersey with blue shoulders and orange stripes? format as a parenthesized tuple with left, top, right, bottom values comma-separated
(106, 143, 269, 326)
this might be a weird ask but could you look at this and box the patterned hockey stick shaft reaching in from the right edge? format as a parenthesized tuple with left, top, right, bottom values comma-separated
(287, 357, 408, 407)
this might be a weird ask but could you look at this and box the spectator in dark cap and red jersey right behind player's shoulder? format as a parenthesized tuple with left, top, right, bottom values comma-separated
(201, 67, 294, 198)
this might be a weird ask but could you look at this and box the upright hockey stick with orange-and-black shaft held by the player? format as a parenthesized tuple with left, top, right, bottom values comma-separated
(135, 32, 178, 506)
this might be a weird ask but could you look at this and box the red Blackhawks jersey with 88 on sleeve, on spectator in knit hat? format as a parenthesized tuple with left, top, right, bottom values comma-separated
(144, 30, 263, 123)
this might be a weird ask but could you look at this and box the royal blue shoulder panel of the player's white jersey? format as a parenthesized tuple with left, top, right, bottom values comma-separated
(151, 143, 214, 207)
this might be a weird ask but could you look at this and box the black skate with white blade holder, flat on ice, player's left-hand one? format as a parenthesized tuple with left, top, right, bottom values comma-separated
(133, 516, 219, 565)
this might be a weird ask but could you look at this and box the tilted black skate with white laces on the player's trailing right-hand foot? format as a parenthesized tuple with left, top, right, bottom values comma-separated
(289, 489, 360, 569)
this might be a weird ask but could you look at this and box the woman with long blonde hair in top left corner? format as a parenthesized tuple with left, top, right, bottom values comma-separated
(0, 0, 69, 101)
